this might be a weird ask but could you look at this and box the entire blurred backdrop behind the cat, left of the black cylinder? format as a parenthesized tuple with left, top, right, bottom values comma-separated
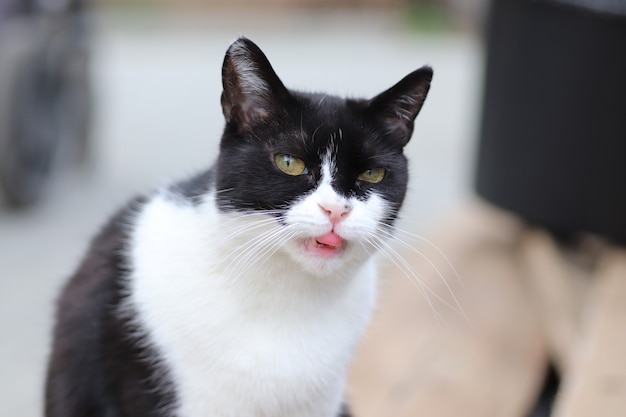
(0, 0, 622, 417)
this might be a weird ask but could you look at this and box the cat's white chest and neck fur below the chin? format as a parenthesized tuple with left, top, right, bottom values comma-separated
(122, 196, 375, 417)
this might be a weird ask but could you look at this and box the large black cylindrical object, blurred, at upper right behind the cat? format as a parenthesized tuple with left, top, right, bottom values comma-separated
(476, 0, 626, 244)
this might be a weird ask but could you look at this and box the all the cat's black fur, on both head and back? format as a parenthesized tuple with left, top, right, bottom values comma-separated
(45, 39, 432, 417)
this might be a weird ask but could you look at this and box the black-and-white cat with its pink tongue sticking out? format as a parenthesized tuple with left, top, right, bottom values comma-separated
(45, 38, 433, 417)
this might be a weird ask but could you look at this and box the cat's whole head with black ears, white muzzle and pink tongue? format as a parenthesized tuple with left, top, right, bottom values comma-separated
(216, 38, 432, 275)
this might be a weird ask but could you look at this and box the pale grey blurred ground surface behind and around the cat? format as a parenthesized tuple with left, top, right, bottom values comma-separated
(0, 14, 482, 417)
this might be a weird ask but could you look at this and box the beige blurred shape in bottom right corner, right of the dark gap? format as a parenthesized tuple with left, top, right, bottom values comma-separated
(554, 249, 626, 417)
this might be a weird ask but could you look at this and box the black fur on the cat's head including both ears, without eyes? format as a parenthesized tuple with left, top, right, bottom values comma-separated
(216, 39, 432, 226)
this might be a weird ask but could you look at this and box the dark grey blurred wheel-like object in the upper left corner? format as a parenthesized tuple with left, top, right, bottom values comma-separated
(0, 0, 91, 208)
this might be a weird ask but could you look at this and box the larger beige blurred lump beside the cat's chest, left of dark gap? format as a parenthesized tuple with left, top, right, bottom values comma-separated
(349, 203, 547, 417)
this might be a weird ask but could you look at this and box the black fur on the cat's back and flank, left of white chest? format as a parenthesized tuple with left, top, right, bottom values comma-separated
(45, 199, 175, 417)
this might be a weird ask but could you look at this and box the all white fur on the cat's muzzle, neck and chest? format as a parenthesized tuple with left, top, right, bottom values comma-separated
(128, 164, 386, 417)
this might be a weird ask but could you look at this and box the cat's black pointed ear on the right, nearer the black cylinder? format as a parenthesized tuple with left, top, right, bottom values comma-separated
(369, 66, 433, 146)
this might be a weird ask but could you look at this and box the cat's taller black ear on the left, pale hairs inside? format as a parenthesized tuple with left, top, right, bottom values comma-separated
(222, 38, 289, 131)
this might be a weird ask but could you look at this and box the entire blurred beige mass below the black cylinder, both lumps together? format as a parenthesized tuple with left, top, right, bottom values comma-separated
(348, 202, 626, 417)
